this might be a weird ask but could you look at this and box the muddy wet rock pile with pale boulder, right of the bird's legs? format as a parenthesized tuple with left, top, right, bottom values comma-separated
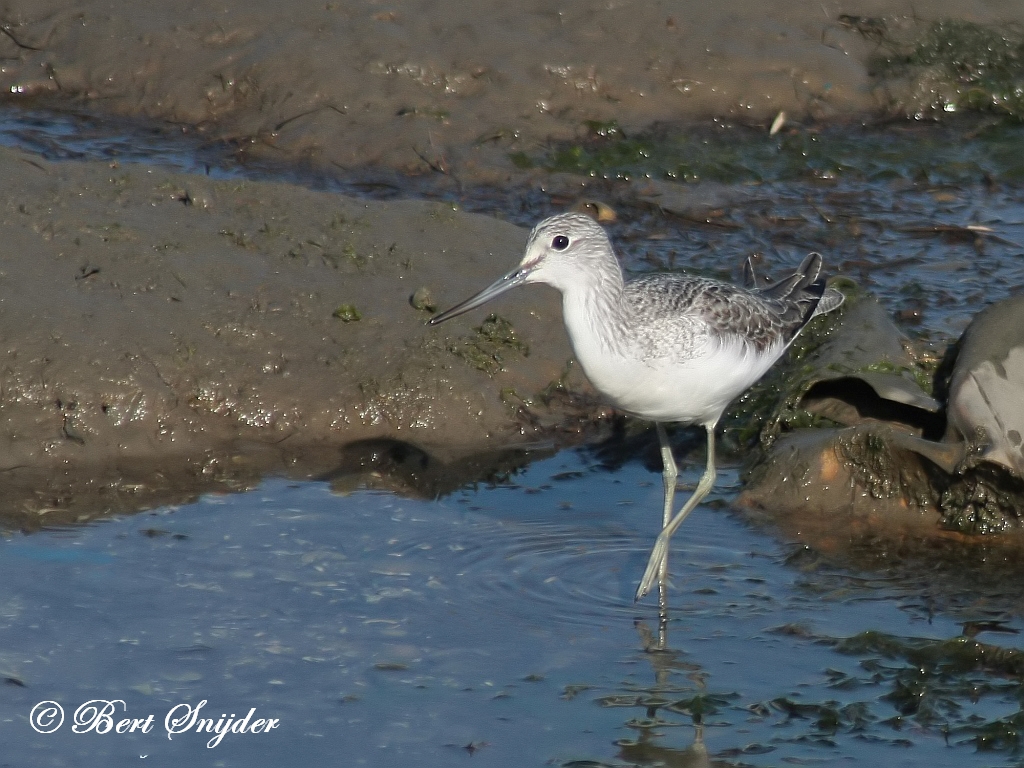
(738, 290, 1024, 534)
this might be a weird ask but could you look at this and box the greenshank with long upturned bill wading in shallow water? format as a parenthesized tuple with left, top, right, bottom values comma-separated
(430, 213, 843, 606)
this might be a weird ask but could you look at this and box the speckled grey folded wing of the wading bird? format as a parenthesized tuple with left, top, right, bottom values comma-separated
(626, 271, 824, 350)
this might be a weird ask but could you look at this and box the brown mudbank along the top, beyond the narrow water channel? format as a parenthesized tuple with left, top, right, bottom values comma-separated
(0, 0, 1024, 179)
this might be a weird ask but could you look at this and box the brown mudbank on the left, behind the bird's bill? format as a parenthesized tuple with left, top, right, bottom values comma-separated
(0, 144, 606, 519)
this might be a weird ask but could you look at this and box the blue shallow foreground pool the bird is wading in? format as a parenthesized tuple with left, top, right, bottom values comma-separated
(6, 452, 1022, 766)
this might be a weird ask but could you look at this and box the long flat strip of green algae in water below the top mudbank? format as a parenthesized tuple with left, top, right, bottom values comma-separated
(524, 114, 1024, 184)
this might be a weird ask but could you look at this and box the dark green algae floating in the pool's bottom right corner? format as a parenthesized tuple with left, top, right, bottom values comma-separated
(598, 623, 1024, 765)
